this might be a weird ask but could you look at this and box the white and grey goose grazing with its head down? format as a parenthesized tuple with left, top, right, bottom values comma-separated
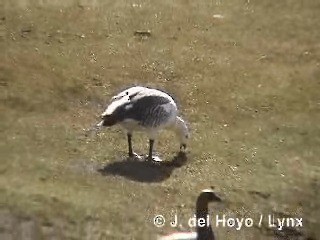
(97, 86, 189, 162)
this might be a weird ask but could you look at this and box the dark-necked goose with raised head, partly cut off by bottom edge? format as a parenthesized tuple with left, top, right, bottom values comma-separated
(158, 189, 222, 240)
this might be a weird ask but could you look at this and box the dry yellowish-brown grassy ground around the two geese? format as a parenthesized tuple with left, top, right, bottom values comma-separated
(0, 0, 320, 240)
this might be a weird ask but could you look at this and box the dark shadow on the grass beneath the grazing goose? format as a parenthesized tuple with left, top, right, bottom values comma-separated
(98, 152, 187, 183)
